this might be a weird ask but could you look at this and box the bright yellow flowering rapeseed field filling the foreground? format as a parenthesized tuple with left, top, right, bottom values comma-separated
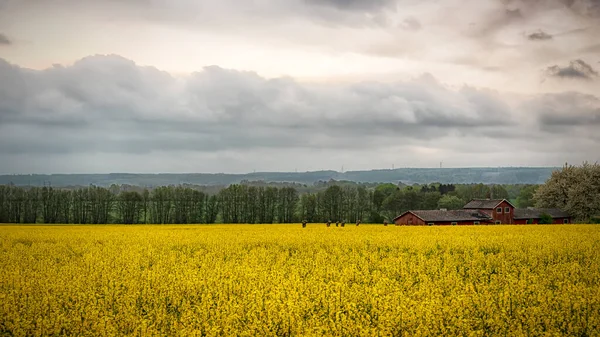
(0, 224, 600, 336)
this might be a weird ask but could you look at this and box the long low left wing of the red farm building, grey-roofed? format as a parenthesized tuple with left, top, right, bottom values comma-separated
(394, 210, 491, 226)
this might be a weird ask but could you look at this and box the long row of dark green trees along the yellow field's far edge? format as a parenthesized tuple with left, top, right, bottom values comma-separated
(0, 184, 524, 224)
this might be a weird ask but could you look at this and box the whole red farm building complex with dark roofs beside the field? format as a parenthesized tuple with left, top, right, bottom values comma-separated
(394, 199, 571, 226)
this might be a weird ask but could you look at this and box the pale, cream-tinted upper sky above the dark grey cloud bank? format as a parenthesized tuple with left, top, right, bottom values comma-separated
(0, 0, 600, 85)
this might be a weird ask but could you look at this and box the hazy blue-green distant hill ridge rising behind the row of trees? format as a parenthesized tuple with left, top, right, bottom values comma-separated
(0, 167, 559, 187)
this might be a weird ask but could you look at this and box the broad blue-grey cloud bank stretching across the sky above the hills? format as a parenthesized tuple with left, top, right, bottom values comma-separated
(0, 55, 600, 173)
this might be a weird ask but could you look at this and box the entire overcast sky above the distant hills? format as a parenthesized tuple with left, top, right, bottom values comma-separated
(0, 0, 600, 174)
